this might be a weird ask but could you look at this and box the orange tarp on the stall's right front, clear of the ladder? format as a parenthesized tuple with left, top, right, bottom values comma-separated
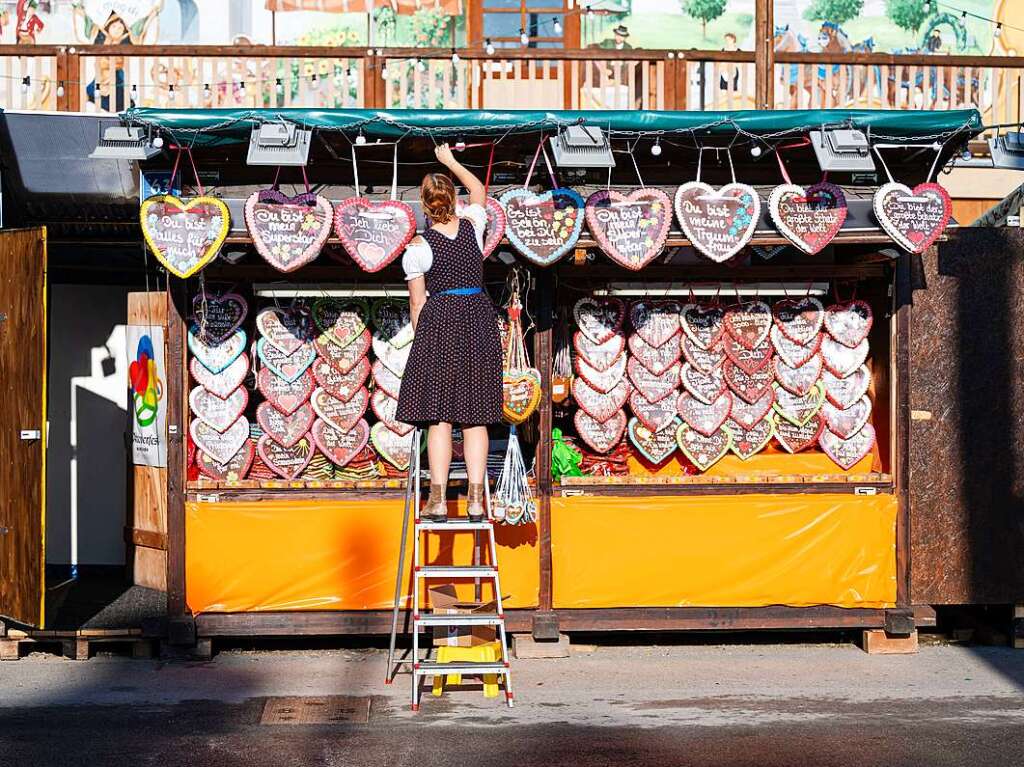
(551, 495, 897, 608)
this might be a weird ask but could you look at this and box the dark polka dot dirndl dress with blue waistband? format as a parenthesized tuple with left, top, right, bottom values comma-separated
(395, 218, 502, 427)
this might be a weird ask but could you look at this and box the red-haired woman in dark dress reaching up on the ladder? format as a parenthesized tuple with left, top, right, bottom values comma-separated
(395, 143, 502, 522)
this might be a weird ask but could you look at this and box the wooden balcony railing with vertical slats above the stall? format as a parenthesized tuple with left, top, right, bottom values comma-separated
(0, 46, 1024, 128)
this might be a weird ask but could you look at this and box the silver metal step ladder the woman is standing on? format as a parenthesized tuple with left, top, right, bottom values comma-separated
(384, 429, 514, 711)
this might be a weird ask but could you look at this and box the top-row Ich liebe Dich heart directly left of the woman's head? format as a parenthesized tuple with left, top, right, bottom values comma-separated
(334, 197, 416, 272)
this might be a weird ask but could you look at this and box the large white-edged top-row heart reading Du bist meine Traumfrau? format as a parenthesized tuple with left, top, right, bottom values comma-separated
(676, 181, 761, 263)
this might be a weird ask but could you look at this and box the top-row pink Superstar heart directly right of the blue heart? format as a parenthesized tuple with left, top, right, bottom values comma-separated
(586, 187, 672, 268)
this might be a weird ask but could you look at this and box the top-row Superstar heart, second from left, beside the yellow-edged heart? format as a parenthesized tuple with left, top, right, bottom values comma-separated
(245, 189, 334, 272)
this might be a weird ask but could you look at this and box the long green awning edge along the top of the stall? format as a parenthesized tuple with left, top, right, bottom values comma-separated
(121, 109, 982, 145)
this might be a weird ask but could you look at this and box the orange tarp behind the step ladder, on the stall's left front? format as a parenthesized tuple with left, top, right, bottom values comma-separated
(185, 500, 539, 614)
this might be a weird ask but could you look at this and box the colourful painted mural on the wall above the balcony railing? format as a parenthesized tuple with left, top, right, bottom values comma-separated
(0, 0, 1024, 54)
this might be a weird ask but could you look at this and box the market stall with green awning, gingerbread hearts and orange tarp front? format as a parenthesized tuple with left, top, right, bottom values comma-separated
(124, 104, 979, 641)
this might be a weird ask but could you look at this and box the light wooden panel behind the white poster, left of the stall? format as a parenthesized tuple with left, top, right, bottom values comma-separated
(125, 291, 167, 591)
